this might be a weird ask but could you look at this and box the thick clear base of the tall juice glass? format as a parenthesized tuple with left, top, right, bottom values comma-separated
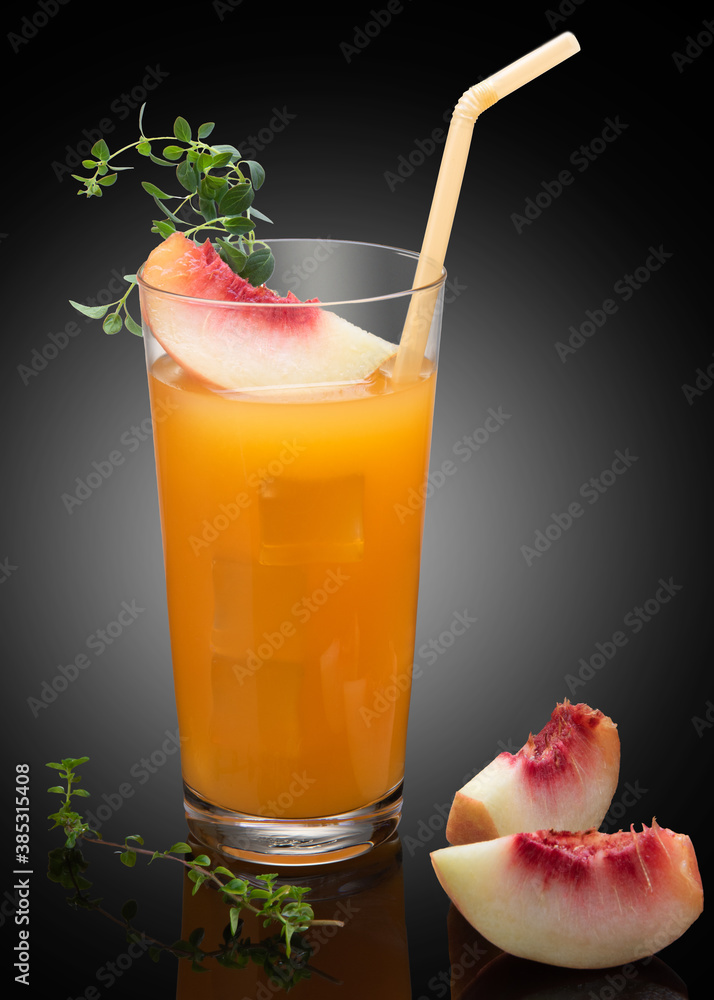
(184, 782, 403, 865)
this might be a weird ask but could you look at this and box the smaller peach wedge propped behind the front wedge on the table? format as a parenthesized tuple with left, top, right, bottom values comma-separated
(446, 699, 620, 844)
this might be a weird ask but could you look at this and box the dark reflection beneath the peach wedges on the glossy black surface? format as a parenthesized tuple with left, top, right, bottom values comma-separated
(447, 903, 689, 1000)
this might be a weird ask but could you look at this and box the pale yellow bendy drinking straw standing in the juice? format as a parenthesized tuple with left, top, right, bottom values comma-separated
(393, 31, 580, 382)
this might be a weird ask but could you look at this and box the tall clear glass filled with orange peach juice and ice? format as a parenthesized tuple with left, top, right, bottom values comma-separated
(139, 240, 445, 864)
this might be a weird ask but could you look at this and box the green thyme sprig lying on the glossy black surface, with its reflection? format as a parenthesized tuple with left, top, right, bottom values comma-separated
(47, 757, 343, 969)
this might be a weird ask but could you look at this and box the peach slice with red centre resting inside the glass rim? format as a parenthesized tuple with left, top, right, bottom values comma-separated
(140, 233, 396, 390)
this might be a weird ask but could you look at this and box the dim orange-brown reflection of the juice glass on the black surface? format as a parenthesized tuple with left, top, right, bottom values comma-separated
(176, 836, 411, 1000)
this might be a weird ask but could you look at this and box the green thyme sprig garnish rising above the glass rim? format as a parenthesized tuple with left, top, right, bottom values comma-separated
(70, 104, 275, 337)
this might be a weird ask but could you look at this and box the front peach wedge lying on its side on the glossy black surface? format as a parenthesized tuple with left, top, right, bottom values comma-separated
(431, 820, 703, 969)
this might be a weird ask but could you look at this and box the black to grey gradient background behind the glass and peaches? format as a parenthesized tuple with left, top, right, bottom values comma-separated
(0, 0, 714, 1000)
